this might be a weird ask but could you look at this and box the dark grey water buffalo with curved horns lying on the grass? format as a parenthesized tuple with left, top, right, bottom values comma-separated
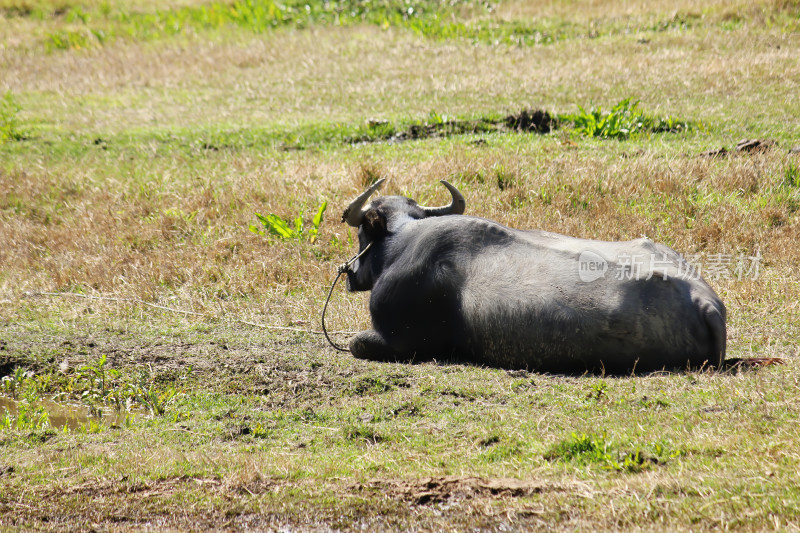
(342, 180, 726, 373)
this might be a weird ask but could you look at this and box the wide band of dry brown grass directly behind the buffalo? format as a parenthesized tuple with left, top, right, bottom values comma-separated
(0, 148, 800, 352)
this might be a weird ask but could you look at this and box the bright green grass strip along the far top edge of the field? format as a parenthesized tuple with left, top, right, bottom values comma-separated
(21, 0, 793, 51)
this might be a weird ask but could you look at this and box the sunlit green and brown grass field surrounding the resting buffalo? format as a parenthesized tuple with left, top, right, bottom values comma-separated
(0, 0, 800, 531)
